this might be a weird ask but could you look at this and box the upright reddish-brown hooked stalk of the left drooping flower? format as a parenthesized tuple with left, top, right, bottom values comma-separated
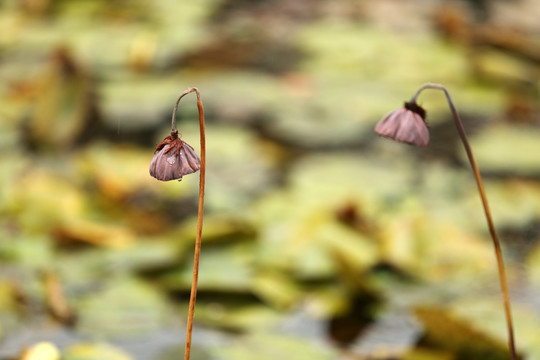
(171, 88, 206, 360)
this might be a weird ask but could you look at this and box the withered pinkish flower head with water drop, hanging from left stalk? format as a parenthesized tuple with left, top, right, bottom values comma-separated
(150, 131, 201, 181)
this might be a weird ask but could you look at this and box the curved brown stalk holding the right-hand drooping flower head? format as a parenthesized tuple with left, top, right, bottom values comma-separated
(411, 83, 517, 360)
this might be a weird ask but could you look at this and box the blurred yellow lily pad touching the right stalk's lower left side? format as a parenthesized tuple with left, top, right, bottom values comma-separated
(380, 207, 495, 281)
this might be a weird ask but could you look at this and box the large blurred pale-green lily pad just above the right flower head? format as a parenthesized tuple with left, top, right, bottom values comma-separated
(297, 21, 466, 84)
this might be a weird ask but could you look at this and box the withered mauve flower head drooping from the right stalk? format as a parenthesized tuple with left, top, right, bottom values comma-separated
(375, 102, 429, 146)
